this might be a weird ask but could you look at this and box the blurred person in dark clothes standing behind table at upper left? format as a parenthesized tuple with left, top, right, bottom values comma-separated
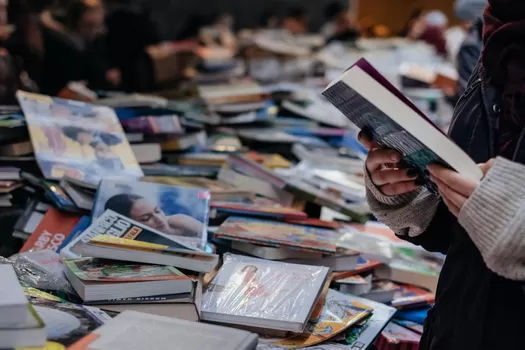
(37, 0, 121, 95)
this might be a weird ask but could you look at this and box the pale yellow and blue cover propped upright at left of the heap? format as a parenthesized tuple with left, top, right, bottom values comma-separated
(17, 91, 143, 183)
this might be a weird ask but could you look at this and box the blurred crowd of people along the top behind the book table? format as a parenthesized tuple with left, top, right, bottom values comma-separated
(0, 0, 484, 104)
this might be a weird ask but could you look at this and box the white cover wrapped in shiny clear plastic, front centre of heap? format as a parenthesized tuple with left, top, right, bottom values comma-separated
(202, 254, 329, 330)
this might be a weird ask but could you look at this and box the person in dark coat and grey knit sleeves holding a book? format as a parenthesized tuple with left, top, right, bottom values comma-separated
(361, 0, 525, 350)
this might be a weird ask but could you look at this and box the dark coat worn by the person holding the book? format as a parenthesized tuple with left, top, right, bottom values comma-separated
(404, 65, 525, 350)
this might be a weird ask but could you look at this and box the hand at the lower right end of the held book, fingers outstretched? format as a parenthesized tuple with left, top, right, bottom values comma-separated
(428, 159, 494, 217)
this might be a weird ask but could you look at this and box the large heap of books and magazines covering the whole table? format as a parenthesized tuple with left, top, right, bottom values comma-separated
(0, 41, 454, 350)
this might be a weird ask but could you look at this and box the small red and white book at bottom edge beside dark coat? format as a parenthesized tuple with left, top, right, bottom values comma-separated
(374, 322, 421, 350)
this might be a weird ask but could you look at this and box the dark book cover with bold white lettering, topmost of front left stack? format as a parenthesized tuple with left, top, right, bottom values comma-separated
(61, 209, 203, 258)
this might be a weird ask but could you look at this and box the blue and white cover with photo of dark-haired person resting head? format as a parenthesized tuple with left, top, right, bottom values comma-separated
(92, 180, 210, 248)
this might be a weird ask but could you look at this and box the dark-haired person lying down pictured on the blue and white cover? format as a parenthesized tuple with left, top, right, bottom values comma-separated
(104, 194, 203, 237)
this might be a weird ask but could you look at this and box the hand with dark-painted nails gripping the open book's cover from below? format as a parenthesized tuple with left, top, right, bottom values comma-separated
(359, 129, 422, 196)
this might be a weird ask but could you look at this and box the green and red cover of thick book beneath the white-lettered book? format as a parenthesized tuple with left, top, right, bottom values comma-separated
(65, 258, 189, 282)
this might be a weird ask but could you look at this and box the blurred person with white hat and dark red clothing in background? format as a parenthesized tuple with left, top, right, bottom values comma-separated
(408, 10, 448, 58)
